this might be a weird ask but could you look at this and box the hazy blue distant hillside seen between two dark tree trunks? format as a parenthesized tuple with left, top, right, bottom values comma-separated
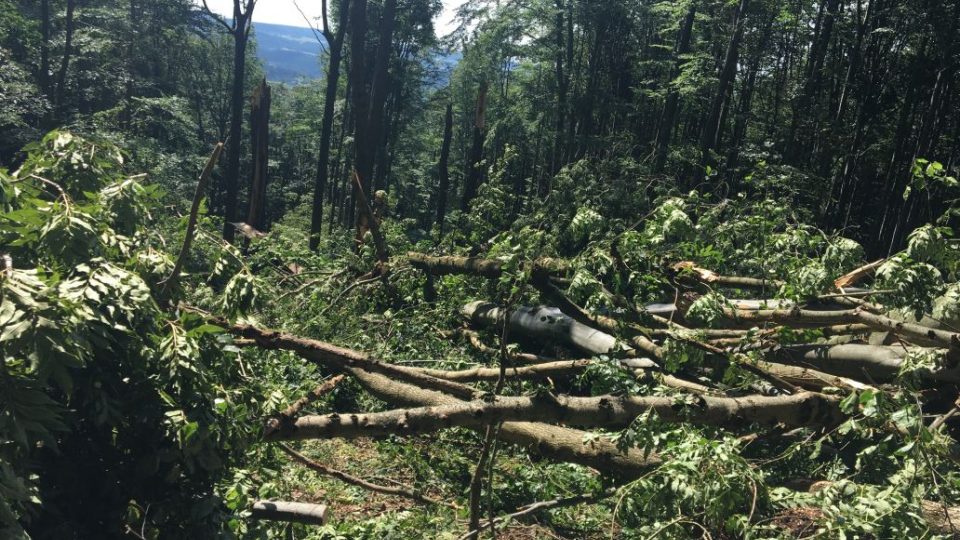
(253, 23, 323, 84)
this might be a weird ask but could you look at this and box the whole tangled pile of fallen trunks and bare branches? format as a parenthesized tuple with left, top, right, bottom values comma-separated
(216, 253, 960, 538)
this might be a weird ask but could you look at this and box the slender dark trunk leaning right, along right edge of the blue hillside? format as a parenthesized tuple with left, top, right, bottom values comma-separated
(310, 0, 350, 251)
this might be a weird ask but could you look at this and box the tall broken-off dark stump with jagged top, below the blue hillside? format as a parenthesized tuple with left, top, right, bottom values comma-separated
(247, 79, 270, 231)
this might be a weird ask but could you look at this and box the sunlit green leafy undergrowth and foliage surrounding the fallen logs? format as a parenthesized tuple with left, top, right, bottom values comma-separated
(0, 133, 960, 539)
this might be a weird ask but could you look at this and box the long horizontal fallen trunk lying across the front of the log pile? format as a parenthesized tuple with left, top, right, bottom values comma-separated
(266, 392, 845, 440)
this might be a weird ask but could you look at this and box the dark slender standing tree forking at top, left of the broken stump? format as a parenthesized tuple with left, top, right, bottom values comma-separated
(203, 0, 257, 242)
